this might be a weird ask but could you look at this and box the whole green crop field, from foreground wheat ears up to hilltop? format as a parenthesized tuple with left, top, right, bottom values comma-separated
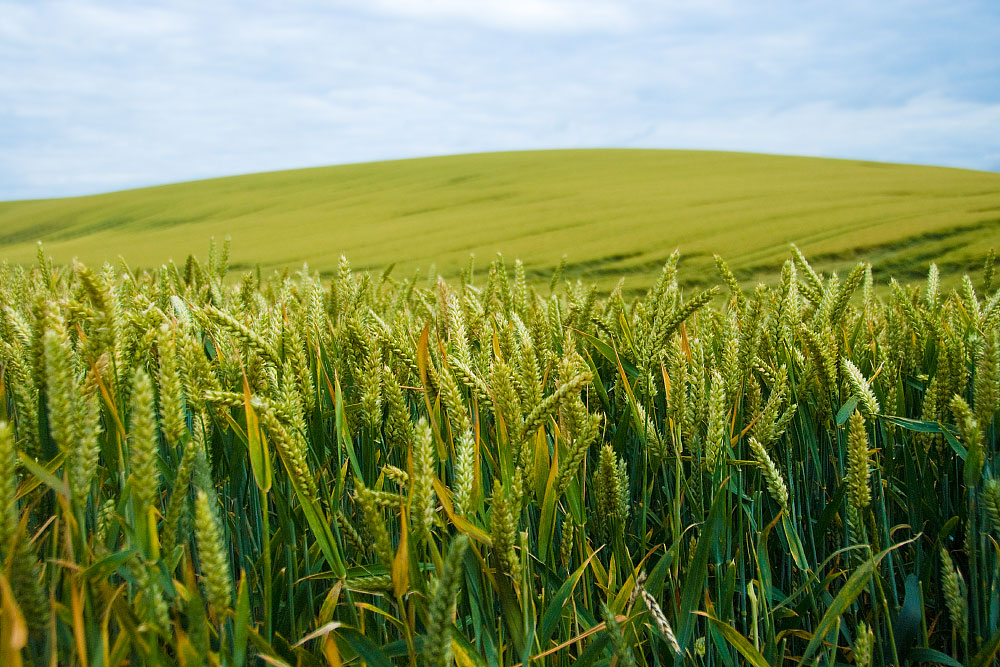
(0, 151, 1000, 667)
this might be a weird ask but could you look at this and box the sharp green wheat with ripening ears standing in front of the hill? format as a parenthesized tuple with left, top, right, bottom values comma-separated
(0, 244, 1000, 667)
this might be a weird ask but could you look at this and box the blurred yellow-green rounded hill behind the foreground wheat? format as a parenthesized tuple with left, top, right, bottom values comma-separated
(0, 150, 1000, 288)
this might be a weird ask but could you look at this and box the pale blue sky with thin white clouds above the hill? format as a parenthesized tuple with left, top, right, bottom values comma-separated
(0, 0, 1000, 200)
